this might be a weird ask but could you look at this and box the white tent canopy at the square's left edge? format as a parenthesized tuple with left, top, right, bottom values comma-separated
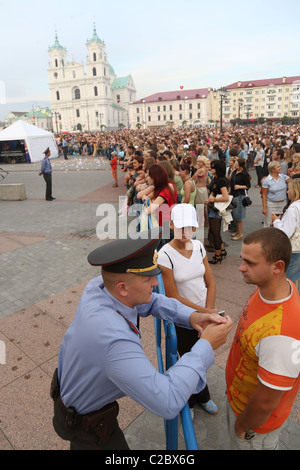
(0, 120, 58, 162)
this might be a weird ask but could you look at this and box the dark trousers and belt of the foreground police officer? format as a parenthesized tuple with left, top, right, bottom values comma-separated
(51, 371, 129, 450)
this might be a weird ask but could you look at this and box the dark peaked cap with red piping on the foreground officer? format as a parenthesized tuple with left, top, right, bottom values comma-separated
(88, 228, 161, 276)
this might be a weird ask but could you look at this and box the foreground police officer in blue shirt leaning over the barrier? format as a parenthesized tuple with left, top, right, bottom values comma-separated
(51, 229, 232, 450)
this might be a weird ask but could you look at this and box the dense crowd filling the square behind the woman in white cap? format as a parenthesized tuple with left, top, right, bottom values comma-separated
(57, 124, 300, 280)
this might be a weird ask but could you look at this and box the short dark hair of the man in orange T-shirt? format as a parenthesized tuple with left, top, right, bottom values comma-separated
(244, 227, 292, 272)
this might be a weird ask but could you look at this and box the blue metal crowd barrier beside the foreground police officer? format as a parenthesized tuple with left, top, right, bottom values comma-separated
(140, 200, 198, 450)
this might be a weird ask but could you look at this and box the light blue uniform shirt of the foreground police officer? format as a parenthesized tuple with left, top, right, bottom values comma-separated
(58, 276, 214, 419)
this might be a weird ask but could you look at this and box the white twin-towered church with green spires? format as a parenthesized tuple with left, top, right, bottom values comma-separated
(48, 25, 136, 133)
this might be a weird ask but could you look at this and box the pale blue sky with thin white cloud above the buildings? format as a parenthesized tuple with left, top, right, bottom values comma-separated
(0, 0, 300, 120)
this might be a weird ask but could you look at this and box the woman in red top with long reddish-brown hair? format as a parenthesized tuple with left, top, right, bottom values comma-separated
(146, 164, 177, 244)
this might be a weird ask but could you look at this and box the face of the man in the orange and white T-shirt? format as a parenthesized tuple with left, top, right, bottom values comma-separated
(239, 243, 275, 287)
